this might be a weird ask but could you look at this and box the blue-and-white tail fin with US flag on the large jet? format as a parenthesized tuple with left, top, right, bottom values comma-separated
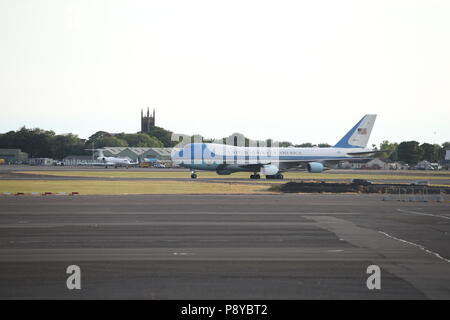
(334, 114, 377, 148)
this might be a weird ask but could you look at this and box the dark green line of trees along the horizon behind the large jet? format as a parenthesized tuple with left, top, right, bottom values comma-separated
(0, 126, 450, 165)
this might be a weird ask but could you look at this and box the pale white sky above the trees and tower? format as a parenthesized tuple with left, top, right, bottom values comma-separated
(0, 0, 450, 144)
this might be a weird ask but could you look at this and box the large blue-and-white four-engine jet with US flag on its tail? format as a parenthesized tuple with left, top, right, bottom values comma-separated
(171, 114, 383, 179)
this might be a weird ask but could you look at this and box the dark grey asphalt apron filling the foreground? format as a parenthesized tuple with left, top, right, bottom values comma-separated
(0, 194, 450, 299)
